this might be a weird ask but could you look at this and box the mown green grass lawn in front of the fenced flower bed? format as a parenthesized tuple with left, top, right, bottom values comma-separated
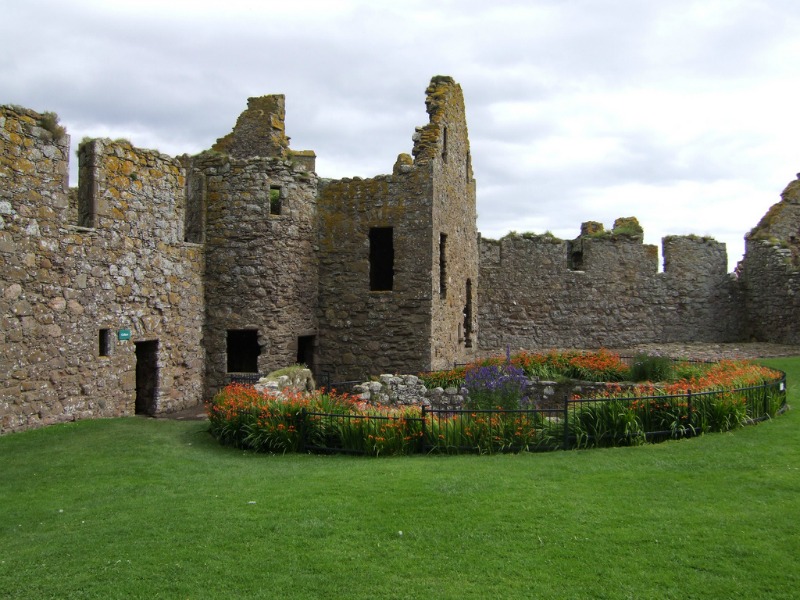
(0, 358, 800, 599)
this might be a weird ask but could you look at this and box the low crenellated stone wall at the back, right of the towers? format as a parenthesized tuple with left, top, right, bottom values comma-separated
(478, 227, 741, 353)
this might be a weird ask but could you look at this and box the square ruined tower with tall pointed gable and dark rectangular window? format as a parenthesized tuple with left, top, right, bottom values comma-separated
(317, 77, 478, 381)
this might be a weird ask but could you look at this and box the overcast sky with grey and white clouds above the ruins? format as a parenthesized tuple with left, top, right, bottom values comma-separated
(0, 0, 800, 269)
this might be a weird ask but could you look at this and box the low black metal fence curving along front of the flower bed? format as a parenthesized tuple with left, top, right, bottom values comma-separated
(219, 374, 786, 455)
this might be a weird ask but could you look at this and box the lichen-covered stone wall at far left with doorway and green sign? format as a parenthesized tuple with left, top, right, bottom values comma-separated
(0, 107, 204, 432)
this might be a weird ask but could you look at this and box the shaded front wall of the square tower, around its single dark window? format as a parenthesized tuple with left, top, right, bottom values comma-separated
(318, 165, 433, 382)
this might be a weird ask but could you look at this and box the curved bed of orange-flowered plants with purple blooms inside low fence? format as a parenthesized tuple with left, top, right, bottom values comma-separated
(208, 351, 786, 456)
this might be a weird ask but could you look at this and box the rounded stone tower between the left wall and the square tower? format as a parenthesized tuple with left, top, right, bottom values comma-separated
(184, 95, 318, 394)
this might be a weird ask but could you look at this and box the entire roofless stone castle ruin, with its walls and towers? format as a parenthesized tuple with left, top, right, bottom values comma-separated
(0, 77, 800, 433)
